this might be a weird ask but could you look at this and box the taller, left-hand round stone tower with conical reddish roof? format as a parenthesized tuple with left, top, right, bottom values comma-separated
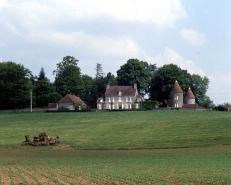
(170, 81, 183, 108)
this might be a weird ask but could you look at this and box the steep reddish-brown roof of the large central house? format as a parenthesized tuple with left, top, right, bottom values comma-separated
(105, 86, 136, 96)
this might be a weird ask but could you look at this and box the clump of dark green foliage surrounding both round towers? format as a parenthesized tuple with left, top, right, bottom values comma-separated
(149, 64, 209, 106)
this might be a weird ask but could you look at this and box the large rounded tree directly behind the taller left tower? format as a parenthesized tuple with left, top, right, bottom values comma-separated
(149, 64, 190, 106)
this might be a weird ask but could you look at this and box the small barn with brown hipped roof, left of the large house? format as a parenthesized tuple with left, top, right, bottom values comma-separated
(58, 94, 87, 110)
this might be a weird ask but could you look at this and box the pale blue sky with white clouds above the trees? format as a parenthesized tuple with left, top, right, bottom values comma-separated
(0, 0, 231, 104)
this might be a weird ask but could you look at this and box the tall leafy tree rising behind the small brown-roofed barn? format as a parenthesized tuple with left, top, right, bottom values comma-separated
(53, 56, 85, 96)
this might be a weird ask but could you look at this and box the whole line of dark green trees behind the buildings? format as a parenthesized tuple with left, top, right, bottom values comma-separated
(0, 56, 212, 110)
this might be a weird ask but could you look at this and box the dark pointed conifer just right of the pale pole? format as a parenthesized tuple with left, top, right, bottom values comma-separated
(34, 68, 62, 107)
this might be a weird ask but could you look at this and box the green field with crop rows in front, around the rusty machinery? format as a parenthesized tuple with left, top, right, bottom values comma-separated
(0, 111, 231, 184)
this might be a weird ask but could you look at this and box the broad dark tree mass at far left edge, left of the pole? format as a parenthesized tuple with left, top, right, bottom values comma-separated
(0, 62, 32, 109)
